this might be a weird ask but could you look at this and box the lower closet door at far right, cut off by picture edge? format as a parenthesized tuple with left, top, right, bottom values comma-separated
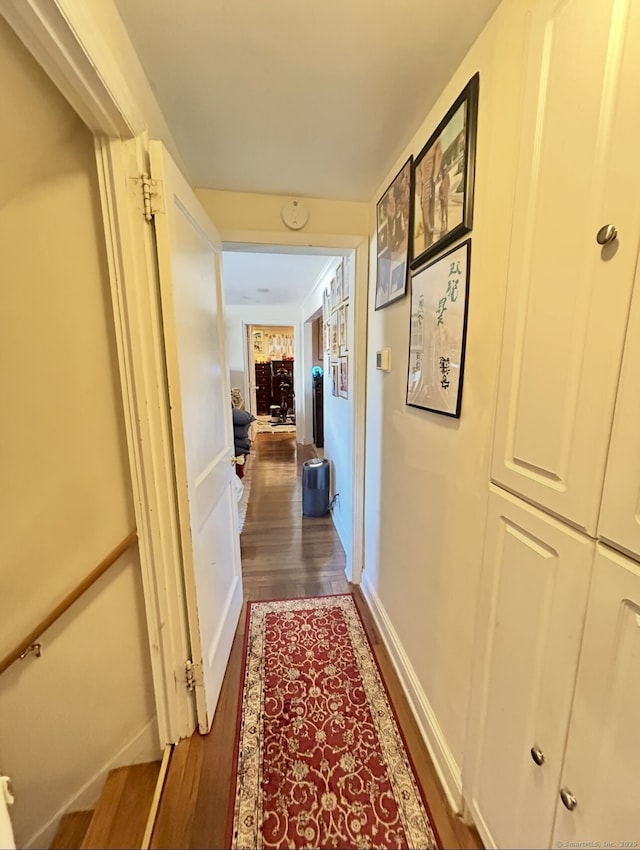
(552, 546, 640, 850)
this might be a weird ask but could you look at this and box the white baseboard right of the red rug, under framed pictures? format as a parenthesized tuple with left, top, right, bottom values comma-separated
(360, 574, 463, 814)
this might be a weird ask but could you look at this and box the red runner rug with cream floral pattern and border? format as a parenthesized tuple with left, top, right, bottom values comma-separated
(231, 595, 437, 850)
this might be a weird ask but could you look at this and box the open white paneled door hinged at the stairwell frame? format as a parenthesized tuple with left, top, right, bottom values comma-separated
(149, 142, 242, 733)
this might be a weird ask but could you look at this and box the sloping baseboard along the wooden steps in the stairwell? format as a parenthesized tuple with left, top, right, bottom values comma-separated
(24, 717, 162, 850)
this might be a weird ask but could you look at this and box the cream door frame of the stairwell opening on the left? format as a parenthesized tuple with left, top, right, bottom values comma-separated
(0, 0, 196, 747)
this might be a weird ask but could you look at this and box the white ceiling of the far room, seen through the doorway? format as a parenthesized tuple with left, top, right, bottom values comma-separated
(222, 251, 331, 307)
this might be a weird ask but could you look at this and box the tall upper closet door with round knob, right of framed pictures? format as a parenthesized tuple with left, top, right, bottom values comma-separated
(492, 0, 640, 536)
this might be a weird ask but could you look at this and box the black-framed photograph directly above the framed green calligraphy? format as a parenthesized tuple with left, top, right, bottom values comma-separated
(411, 74, 480, 269)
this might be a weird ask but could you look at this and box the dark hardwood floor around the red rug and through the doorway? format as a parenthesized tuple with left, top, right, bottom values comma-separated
(151, 433, 482, 850)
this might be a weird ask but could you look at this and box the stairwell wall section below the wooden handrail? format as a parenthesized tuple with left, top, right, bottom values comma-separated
(0, 550, 161, 847)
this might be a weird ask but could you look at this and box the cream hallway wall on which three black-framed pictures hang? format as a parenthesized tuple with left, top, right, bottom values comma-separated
(363, 0, 526, 806)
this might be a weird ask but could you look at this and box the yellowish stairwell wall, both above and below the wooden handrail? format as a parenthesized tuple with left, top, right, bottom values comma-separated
(0, 19, 158, 845)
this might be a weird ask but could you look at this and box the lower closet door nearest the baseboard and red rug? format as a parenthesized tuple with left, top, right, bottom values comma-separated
(467, 487, 595, 848)
